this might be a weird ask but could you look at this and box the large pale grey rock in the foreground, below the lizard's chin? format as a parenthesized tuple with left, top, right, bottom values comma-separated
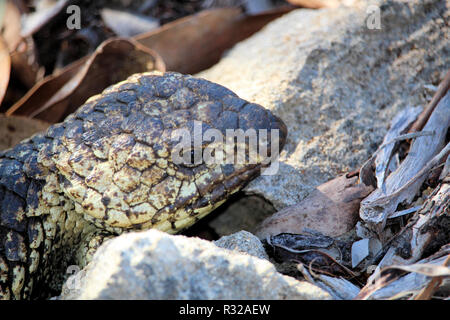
(61, 230, 330, 299)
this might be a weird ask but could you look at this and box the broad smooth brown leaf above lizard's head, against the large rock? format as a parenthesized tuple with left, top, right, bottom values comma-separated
(135, 7, 292, 74)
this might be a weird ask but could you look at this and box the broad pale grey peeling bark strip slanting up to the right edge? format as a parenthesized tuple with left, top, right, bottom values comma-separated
(360, 92, 450, 232)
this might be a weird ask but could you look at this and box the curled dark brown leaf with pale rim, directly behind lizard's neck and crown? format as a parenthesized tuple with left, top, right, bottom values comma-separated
(6, 38, 165, 123)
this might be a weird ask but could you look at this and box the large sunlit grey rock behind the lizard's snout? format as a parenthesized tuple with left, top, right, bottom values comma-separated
(199, 0, 450, 209)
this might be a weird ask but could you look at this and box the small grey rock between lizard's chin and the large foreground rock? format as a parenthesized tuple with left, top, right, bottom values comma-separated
(214, 231, 269, 260)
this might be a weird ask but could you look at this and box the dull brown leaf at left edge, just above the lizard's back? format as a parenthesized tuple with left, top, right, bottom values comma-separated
(0, 114, 50, 150)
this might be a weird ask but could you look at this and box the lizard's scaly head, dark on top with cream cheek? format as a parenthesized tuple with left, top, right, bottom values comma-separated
(53, 73, 287, 233)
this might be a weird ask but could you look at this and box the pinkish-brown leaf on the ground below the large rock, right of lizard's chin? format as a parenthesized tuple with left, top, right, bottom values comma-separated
(256, 175, 373, 238)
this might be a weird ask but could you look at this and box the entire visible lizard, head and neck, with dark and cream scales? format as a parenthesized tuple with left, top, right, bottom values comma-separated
(0, 73, 287, 299)
